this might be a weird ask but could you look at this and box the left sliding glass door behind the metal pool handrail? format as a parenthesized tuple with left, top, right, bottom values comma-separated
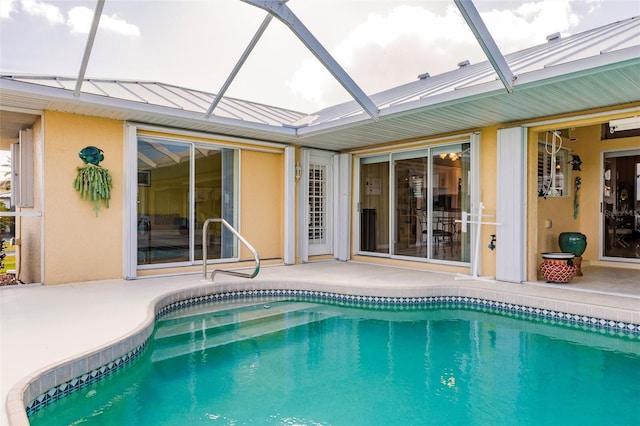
(137, 135, 237, 265)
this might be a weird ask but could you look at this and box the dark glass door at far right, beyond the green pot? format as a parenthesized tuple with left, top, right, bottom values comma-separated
(602, 150, 640, 261)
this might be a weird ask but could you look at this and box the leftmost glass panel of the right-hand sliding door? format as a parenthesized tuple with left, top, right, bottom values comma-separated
(360, 156, 389, 253)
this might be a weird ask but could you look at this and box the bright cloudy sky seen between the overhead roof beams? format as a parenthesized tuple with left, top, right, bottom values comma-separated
(0, 0, 640, 113)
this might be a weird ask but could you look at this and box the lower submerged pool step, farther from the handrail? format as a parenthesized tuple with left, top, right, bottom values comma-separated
(151, 310, 335, 362)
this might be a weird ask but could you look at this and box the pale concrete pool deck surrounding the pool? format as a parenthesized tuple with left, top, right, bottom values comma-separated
(0, 261, 640, 425)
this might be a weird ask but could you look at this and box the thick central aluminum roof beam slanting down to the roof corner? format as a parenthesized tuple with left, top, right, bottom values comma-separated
(242, 0, 378, 121)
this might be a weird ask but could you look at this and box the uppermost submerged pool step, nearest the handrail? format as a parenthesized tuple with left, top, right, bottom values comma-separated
(154, 301, 317, 340)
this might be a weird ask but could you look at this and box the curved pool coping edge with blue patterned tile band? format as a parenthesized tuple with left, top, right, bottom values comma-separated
(6, 280, 640, 425)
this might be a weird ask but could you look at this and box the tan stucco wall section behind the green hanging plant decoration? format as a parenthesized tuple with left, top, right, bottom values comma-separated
(43, 111, 124, 284)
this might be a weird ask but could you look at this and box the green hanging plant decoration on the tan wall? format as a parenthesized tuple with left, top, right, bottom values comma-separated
(73, 146, 113, 216)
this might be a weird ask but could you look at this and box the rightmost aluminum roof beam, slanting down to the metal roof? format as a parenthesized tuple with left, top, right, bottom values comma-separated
(453, 0, 516, 93)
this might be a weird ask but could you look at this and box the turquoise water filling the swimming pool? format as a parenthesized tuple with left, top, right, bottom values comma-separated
(30, 299, 640, 425)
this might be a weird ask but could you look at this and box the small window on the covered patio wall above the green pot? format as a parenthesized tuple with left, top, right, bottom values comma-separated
(538, 132, 570, 198)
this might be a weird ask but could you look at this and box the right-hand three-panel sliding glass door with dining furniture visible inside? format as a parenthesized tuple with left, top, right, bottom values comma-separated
(359, 143, 471, 262)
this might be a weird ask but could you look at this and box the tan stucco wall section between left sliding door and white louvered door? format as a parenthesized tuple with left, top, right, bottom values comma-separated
(240, 151, 284, 259)
